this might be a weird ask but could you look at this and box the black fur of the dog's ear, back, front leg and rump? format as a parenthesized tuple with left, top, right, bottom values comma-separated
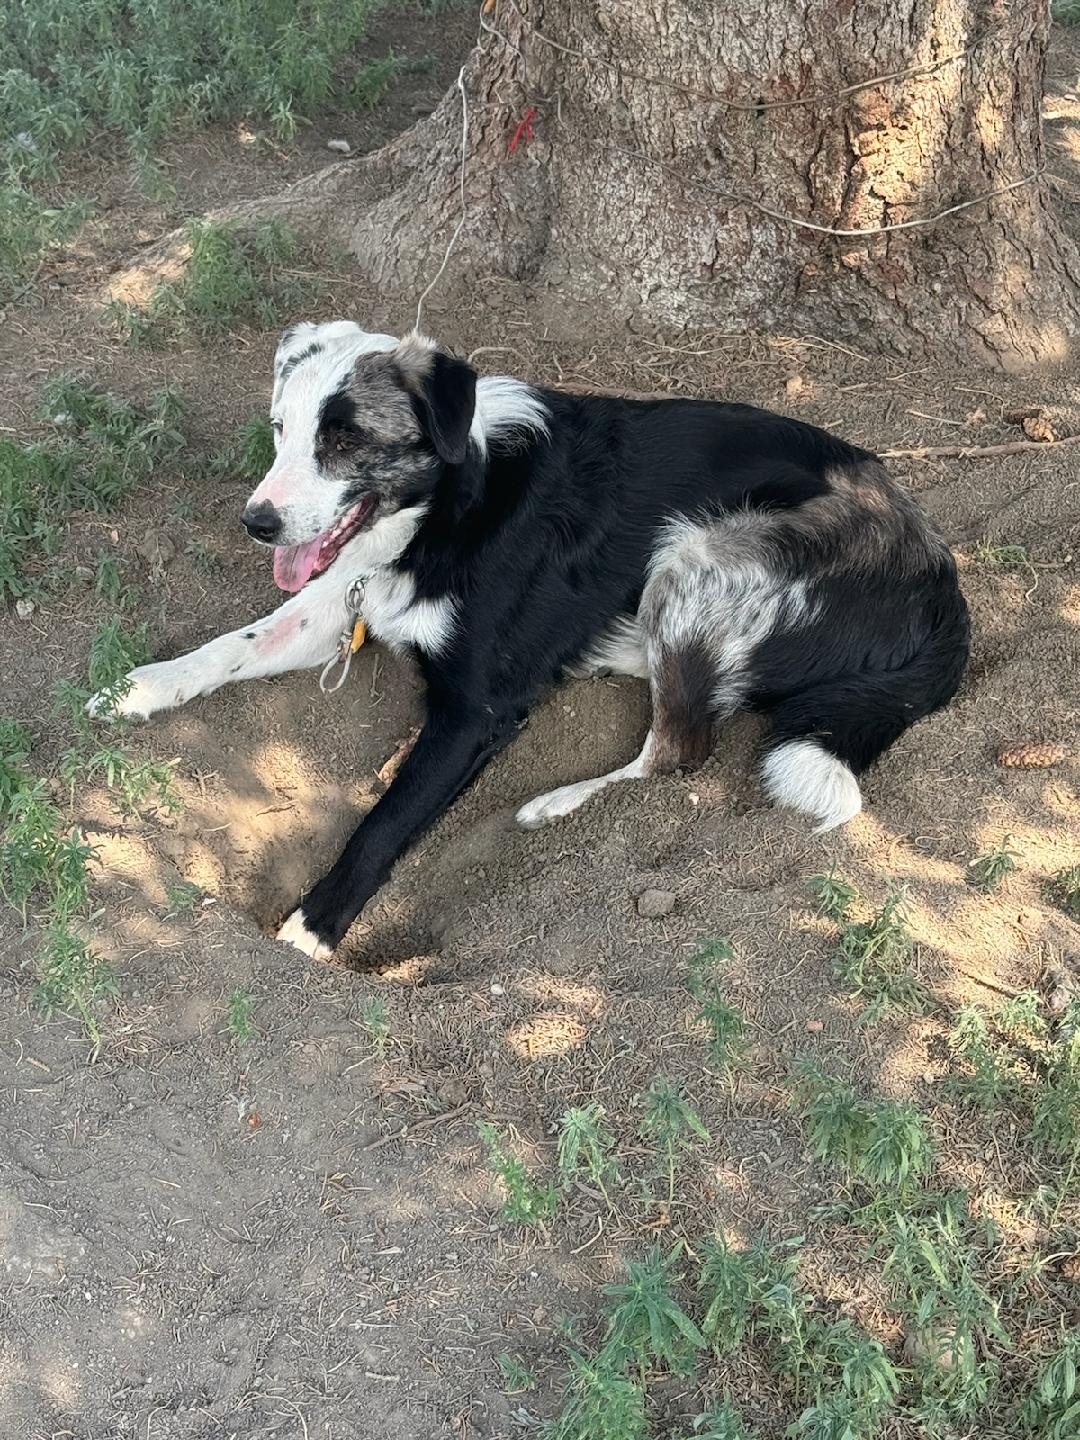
(292, 383, 968, 946)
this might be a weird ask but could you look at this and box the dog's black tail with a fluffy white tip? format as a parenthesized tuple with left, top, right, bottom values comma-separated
(762, 596, 968, 832)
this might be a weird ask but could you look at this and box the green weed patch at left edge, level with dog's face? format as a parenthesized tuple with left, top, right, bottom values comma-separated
(0, 376, 184, 602)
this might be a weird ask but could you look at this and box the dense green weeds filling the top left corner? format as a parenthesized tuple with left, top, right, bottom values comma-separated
(0, 0, 380, 288)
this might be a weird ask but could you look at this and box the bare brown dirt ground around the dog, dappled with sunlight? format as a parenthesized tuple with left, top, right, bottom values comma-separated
(0, 12, 1080, 1440)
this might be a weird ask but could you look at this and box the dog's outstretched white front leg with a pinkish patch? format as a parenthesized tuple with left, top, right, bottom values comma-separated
(86, 570, 347, 720)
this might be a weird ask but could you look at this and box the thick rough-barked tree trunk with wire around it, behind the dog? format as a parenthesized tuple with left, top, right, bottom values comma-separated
(264, 0, 1080, 367)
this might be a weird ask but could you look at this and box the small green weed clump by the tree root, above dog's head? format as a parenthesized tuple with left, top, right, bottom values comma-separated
(120, 220, 314, 344)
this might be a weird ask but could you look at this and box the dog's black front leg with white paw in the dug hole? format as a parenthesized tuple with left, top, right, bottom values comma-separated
(278, 711, 517, 959)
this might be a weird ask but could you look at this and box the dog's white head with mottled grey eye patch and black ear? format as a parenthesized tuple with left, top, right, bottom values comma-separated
(243, 321, 477, 590)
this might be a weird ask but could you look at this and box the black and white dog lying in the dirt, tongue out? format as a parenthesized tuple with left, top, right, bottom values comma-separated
(91, 321, 968, 956)
